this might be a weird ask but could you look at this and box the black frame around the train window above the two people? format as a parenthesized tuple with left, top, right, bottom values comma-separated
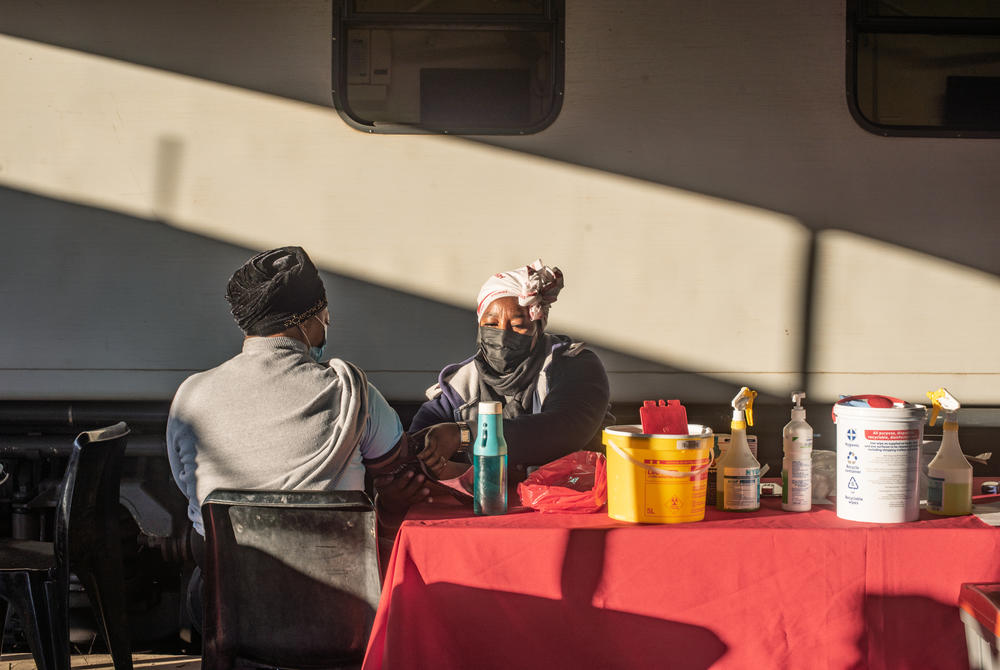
(331, 0, 566, 135)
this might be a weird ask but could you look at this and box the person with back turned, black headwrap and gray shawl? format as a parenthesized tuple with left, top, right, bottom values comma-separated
(167, 247, 434, 562)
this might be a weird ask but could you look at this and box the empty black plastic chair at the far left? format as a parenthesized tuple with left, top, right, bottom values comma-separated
(0, 423, 132, 670)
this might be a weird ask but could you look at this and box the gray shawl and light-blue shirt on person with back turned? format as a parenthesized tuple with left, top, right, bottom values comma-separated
(167, 337, 402, 535)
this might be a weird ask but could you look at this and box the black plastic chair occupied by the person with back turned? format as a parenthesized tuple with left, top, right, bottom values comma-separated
(201, 490, 381, 670)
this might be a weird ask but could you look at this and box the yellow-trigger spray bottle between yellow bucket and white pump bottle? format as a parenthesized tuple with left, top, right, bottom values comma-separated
(715, 386, 760, 512)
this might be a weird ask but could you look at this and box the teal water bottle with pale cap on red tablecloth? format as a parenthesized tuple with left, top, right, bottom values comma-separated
(472, 402, 507, 514)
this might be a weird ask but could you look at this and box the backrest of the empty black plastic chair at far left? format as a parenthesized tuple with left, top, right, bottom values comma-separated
(55, 422, 129, 583)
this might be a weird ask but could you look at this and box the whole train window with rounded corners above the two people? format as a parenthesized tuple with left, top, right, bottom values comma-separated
(333, 0, 564, 135)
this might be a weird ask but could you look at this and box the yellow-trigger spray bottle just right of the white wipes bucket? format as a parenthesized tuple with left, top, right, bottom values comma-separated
(927, 387, 972, 516)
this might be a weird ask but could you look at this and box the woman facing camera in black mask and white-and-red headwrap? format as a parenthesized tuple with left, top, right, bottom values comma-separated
(410, 260, 614, 482)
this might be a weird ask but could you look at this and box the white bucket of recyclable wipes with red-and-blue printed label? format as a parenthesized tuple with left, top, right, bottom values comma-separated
(833, 396, 927, 523)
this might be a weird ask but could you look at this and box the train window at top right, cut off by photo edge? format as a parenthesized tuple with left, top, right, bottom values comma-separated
(847, 0, 1000, 137)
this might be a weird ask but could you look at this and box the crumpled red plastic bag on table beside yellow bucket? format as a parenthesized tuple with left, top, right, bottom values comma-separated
(517, 451, 608, 512)
